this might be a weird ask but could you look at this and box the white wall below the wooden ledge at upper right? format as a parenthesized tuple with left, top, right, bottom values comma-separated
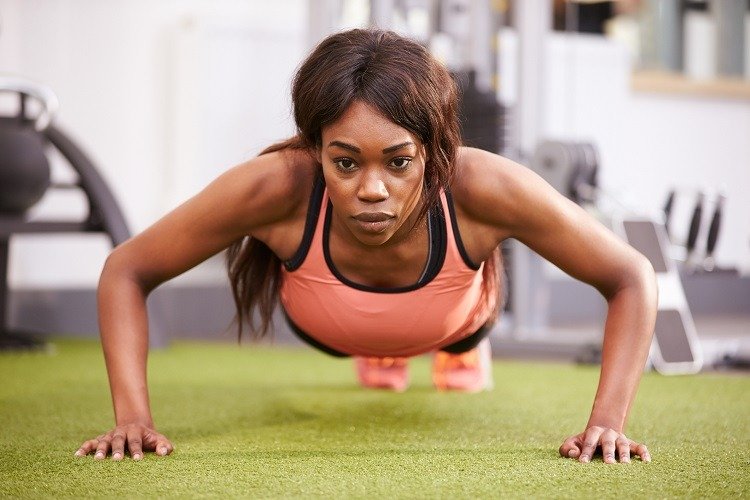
(542, 34, 750, 273)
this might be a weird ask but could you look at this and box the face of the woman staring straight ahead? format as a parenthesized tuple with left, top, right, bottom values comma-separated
(319, 101, 426, 245)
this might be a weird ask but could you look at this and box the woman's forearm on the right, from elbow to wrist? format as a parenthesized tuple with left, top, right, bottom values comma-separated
(587, 265, 657, 432)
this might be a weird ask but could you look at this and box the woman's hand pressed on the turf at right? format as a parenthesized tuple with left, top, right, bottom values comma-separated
(560, 425, 651, 464)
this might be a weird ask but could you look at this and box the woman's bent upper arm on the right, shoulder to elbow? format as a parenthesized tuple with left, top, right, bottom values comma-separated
(452, 150, 647, 296)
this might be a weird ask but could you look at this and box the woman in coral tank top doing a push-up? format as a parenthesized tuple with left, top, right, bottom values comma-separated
(76, 30, 656, 463)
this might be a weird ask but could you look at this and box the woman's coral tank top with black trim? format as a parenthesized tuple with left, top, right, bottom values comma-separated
(280, 179, 490, 357)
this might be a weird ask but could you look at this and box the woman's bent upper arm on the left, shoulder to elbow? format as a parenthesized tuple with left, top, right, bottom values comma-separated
(105, 152, 304, 290)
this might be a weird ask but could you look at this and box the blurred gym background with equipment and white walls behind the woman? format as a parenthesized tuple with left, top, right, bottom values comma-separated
(0, 0, 750, 373)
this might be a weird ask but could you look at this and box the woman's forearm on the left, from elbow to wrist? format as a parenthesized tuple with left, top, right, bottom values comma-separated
(97, 261, 153, 427)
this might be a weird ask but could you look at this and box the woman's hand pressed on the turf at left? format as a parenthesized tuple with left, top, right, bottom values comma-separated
(75, 424, 174, 460)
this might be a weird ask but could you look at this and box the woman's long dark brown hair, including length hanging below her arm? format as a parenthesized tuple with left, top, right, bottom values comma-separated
(227, 29, 502, 336)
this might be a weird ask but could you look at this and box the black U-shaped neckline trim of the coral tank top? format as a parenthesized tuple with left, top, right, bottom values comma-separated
(323, 200, 448, 293)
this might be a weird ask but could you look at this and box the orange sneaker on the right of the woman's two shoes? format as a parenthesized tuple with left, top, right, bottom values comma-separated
(432, 338, 493, 392)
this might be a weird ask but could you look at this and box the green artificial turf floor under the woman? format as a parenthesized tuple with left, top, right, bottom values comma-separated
(0, 340, 750, 498)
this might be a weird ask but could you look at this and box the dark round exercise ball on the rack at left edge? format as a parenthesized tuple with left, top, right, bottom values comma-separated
(0, 119, 50, 215)
